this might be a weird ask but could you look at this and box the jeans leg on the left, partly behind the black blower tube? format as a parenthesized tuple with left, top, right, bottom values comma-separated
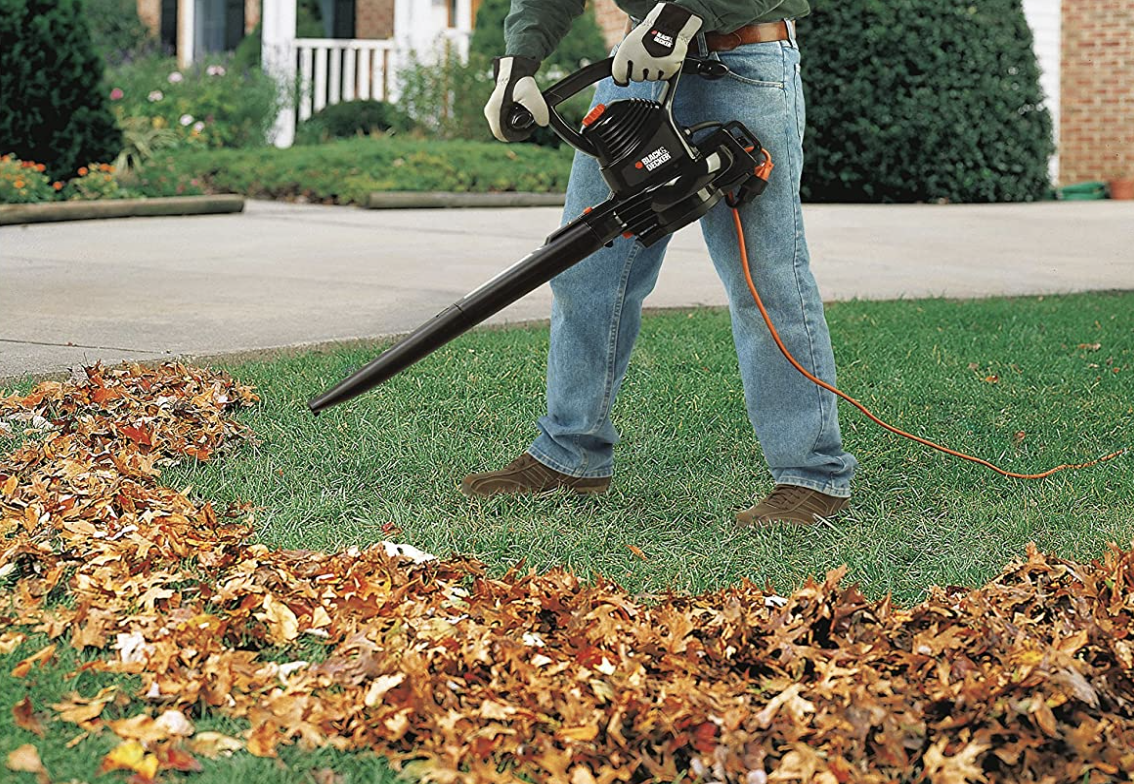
(528, 79, 668, 477)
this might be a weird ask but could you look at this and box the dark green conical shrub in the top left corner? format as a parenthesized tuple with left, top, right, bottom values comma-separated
(0, 0, 121, 179)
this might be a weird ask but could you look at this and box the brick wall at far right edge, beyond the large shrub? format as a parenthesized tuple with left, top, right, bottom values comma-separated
(1059, 0, 1134, 184)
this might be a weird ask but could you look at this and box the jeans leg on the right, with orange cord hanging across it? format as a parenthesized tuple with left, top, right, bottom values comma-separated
(682, 42, 857, 497)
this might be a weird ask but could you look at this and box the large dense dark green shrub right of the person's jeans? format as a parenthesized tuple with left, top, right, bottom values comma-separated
(798, 0, 1053, 202)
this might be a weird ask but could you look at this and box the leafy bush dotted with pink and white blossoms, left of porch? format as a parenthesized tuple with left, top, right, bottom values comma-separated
(107, 57, 280, 152)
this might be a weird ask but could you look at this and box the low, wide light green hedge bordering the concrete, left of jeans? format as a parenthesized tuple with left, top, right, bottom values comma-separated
(130, 137, 572, 204)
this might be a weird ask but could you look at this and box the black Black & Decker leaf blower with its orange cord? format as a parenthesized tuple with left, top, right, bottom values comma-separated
(307, 59, 1127, 479)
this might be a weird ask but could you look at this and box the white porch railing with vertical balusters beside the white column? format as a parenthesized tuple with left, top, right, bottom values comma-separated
(293, 39, 397, 121)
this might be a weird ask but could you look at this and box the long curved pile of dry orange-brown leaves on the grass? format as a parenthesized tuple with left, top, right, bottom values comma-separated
(0, 364, 1134, 784)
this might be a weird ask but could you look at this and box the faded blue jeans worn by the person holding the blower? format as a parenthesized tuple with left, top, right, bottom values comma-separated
(528, 36, 857, 497)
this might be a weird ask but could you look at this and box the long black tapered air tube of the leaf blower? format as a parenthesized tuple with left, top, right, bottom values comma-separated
(307, 220, 611, 414)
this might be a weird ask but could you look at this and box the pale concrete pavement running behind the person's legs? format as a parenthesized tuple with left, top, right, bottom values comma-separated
(0, 196, 1134, 379)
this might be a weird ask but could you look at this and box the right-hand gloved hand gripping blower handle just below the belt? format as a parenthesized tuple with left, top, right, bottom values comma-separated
(611, 2, 701, 86)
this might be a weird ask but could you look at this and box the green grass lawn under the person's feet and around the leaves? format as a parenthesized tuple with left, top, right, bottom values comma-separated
(0, 293, 1134, 784)
